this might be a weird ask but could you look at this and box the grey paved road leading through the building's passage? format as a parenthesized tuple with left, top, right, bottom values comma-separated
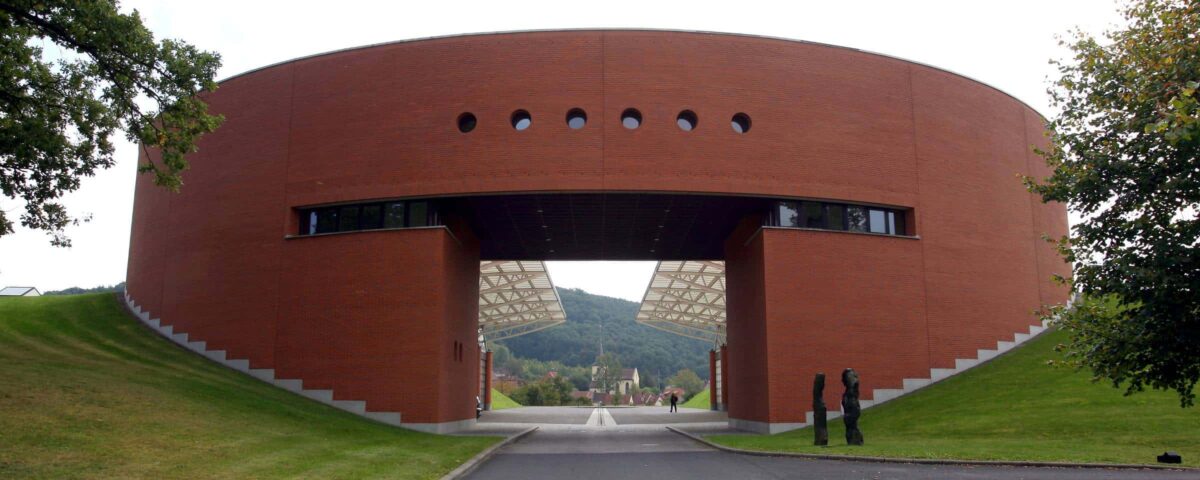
(458, 407, 1200, 480)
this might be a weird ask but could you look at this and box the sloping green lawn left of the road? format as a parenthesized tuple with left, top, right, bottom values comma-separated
(0, 294, 498, 479)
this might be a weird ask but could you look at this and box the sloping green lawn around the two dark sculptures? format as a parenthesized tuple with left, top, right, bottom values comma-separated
(708, 331, 1200, 466)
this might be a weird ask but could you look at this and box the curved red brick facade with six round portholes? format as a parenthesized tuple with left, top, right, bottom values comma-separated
(127, 31, 1068, 430)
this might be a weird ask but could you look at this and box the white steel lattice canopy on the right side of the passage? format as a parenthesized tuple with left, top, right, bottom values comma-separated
(637, 260, 725, 344)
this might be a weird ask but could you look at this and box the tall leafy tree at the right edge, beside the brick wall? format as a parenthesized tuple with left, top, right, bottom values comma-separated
(1025, 0, 1200, 407)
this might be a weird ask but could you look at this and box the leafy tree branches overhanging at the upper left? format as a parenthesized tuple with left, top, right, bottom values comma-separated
(0, 0, 222, 246)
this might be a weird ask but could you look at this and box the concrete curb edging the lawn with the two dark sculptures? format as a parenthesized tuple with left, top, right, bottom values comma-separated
(667, 426, 1200, 472)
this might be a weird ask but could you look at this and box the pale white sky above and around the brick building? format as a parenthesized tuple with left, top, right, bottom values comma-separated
(0, 0, 1121, 301)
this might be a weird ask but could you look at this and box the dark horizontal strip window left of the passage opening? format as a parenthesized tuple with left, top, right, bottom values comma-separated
(300, 200, 442, 235)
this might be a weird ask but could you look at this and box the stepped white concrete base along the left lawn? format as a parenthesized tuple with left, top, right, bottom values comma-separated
(125, 292, 417, 433)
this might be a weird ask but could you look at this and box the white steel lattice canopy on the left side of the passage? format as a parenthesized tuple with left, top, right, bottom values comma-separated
(479, 260, 566, 341)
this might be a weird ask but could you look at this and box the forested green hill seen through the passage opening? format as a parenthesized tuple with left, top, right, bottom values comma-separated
(499, 288, 712, 384)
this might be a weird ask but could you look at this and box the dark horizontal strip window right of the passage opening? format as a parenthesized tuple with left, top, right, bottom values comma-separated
(766, 202, 907, 235)
